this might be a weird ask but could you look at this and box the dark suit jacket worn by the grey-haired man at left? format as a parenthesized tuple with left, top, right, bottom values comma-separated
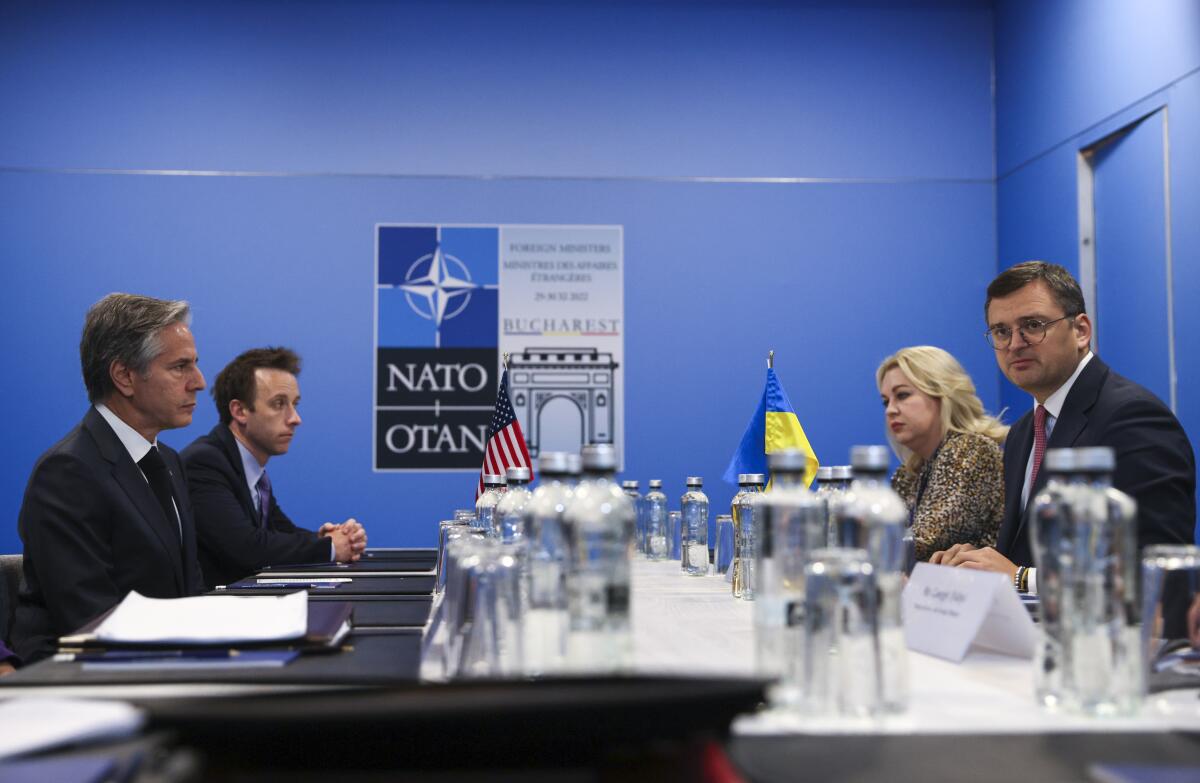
(12, 408, 204, 663)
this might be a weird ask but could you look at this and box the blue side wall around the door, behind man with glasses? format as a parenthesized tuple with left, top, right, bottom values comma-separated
(996, 0, 1200, 533)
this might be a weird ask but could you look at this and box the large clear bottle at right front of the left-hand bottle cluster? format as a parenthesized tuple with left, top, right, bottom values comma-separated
(564, 443, 635, 671)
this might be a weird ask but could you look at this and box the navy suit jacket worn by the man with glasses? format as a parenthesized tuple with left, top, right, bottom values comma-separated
(996, 355, 1196, 566)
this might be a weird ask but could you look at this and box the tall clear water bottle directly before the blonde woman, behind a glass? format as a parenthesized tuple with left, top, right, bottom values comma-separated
(836, 446, 908, 713)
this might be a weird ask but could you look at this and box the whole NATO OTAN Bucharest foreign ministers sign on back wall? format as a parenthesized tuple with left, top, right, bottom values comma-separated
(373, 223, 624, 472)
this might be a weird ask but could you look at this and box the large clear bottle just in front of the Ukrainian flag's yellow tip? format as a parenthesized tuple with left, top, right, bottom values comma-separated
(752, 449, 823, 686)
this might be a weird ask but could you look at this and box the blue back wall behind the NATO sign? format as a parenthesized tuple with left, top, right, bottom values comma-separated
(0, 0, 996, 551)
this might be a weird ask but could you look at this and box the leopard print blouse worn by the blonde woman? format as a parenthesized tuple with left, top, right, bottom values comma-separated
(892, 432, 1004, 561)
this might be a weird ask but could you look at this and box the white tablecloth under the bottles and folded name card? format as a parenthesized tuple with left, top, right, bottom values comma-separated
(631, 558, 1200, 734)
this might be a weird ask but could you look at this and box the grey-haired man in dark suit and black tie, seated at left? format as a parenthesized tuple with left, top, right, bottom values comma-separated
(13, 294, 204, 662)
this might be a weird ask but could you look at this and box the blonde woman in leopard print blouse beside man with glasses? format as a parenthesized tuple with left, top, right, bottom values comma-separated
(875, 346, 1008, 561)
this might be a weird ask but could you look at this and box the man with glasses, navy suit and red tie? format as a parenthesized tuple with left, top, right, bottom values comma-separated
(930, 261, 1196, 593)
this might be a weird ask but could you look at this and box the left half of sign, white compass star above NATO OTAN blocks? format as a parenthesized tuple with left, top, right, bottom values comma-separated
(374, 225, 499, 471)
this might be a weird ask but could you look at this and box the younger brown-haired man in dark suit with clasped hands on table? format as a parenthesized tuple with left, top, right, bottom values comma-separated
(182, 348, 367, 587)
